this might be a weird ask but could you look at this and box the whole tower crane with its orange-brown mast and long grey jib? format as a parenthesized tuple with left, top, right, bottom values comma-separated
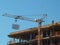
(3, 13, 47, 45)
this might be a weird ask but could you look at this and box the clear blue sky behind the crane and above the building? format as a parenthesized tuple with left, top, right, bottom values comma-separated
(0, 0, 60, 45)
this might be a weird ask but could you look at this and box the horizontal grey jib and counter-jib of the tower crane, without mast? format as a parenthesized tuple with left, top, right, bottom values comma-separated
(2, 13, 47, 22)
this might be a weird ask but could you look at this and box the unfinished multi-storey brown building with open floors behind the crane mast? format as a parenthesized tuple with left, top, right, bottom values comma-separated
(8, 23, 60, 45)
